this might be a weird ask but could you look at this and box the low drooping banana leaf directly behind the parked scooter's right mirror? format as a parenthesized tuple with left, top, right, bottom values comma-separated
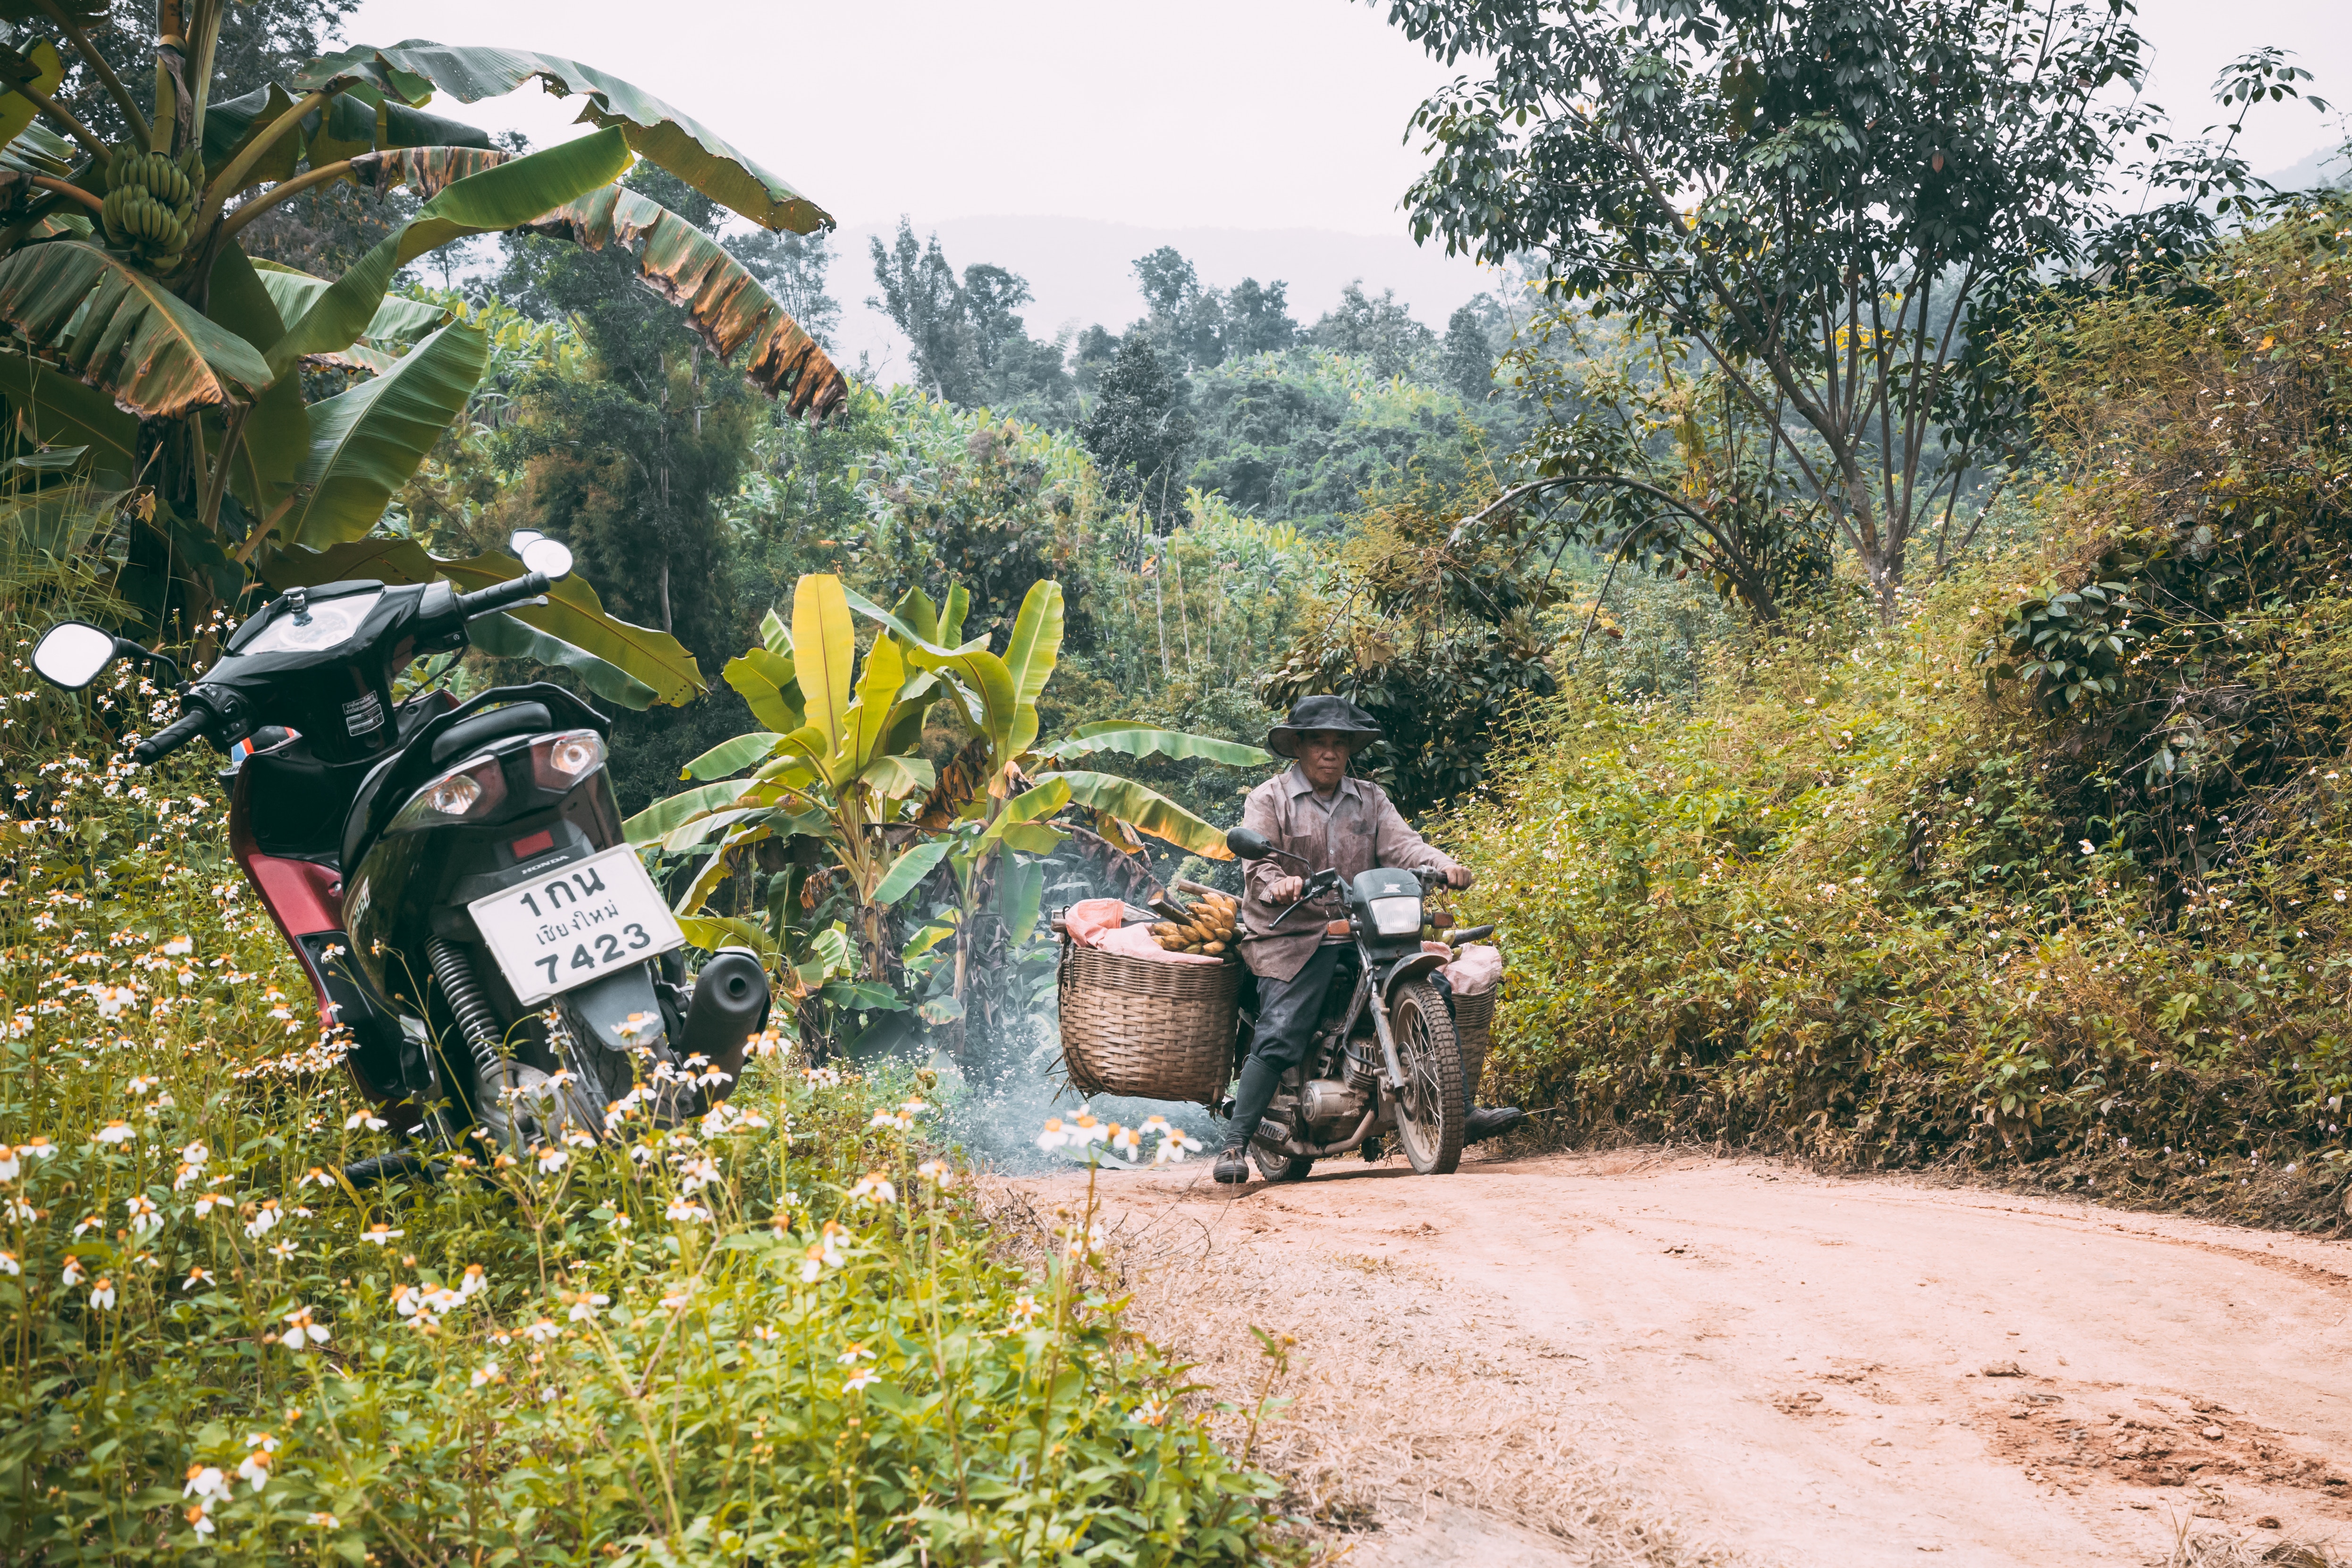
(261, 539, 708, 705)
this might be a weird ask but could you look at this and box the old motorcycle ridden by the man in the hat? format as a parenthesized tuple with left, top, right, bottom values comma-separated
(1225, 827, 1493, 1182)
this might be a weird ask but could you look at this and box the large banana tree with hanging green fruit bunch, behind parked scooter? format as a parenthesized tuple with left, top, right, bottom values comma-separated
(0, 0, 847, 700)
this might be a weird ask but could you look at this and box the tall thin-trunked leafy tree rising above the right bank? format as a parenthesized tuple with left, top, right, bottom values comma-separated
(1390, 0, 2307, 616)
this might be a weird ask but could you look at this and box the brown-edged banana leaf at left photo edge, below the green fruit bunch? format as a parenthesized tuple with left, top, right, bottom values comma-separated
(0, 240, 275, 419)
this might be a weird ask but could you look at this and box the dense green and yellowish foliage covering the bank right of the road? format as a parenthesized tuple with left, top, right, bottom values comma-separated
(1451, 209, 2352, 1213)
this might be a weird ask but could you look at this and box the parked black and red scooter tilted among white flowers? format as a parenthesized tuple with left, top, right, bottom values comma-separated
(33, 534, 769, 1182)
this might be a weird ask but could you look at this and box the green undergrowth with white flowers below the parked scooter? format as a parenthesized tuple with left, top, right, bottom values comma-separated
(0, 564, 1273, 1563)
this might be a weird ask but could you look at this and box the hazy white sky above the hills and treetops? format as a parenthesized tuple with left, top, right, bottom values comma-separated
(348, 0, 2352, 235)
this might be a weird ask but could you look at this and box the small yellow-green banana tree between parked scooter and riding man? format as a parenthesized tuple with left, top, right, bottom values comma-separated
(628, 576, 1270, 1053)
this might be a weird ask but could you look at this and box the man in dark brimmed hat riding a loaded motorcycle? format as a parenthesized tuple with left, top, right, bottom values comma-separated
(1214, 696, 1524, 1182)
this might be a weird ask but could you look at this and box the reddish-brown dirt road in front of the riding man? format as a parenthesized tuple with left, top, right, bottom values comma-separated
(1077, 1154, 2352, 1568)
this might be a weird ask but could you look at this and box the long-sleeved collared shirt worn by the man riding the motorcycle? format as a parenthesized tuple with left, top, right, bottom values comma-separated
(1242, 764, 1453, 980)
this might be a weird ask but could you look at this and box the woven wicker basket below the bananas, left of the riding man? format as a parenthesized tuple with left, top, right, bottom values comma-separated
(1061, 943, 1242, 1105)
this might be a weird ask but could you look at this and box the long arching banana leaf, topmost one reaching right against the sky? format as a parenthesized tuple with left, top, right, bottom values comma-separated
(294, 38, 833, 235)
